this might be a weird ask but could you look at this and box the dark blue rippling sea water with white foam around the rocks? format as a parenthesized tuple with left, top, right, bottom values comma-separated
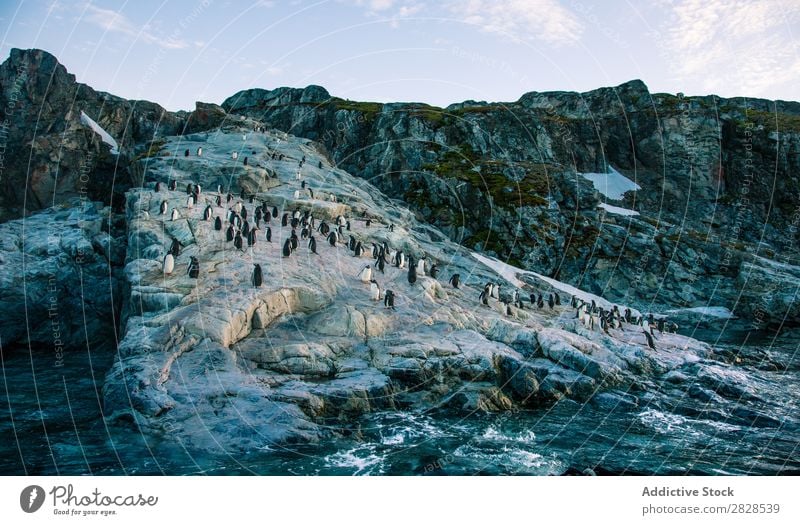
(0, 332, 800, 475)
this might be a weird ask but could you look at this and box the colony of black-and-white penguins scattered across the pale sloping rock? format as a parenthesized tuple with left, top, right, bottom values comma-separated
(154, 128, 678, 350)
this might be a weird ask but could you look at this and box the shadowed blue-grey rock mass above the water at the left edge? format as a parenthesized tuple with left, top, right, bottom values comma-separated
(0, 200, 125, 352)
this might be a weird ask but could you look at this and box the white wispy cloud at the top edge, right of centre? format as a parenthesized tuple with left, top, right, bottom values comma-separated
(448, 0, 583, 46)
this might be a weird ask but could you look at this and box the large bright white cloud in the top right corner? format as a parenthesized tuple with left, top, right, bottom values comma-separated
(664, 0, 800, 97)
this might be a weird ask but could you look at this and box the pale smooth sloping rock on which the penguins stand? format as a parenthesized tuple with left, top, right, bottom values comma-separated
(97, 125, 772, 453)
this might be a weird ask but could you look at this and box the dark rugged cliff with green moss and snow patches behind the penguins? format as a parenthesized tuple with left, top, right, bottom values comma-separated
(222, 81, 800, 324)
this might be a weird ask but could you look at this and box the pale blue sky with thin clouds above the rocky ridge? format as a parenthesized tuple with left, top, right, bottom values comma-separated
(0, 0, 800, 110)
